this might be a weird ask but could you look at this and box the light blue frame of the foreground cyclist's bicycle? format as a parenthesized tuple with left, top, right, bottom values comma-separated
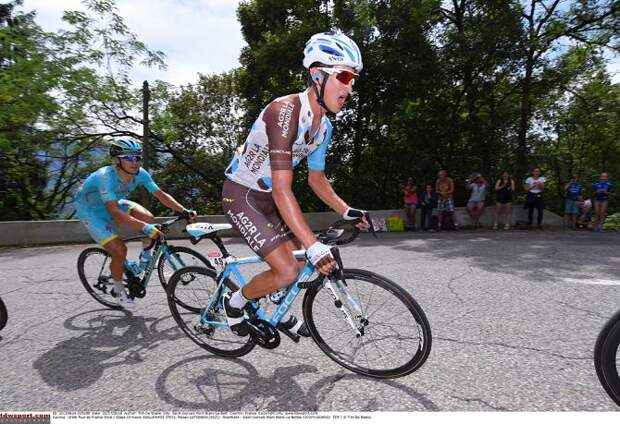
(200, 250, 315, 328)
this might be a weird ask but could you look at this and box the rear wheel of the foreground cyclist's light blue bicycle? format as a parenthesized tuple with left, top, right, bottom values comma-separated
(168, 266, 255, 357)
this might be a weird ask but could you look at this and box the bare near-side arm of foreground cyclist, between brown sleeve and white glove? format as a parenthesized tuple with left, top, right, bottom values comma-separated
(271, 170, 316, 249)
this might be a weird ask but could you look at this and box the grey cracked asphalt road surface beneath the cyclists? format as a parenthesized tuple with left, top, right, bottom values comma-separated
(0, 231, 620, 411)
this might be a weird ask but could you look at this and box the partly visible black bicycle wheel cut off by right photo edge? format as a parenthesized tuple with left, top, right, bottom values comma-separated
(594, 311, 620, 406)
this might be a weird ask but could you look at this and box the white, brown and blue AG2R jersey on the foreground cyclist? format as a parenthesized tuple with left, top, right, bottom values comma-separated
(226, 91, 332, 193)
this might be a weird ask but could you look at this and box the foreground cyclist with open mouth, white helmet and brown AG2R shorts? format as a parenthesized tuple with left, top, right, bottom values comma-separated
(222, 32, 364, 337)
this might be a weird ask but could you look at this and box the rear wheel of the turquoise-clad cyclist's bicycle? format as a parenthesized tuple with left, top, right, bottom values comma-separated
(78, 247, 123, 309)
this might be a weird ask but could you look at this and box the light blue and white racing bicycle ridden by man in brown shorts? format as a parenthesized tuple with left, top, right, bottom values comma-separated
(168, 218, 431, 378)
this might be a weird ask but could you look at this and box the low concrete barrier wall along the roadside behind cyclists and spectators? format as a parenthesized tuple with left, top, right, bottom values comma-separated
(0, 206, 562, 246)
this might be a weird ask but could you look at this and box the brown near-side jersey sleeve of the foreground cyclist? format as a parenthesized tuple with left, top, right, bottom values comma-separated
(263, 94, 301, 171)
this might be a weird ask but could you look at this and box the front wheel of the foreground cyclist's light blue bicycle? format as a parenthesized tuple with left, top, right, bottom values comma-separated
(303, 269, 431, 378)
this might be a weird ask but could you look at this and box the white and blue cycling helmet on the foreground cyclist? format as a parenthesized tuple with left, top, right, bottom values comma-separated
(303, 31, 364, 73)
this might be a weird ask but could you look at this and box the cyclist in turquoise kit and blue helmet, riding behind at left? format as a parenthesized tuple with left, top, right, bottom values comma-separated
(75, 138, 196, 308)
